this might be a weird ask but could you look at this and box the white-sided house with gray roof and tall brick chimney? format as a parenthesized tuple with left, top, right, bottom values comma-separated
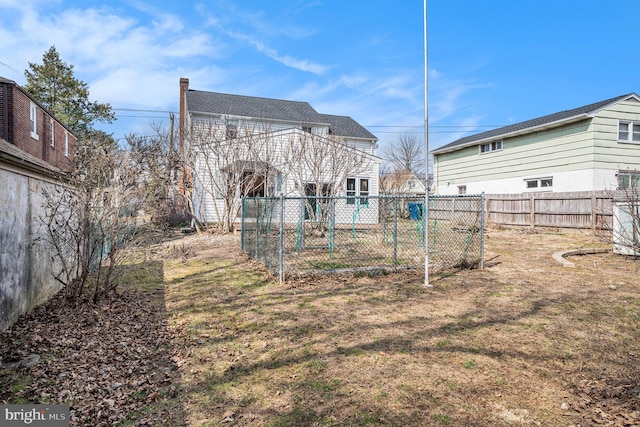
(180, 78, 380, 229)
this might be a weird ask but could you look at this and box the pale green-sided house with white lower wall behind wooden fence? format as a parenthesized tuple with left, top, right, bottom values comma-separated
(432, 93, 640, 194)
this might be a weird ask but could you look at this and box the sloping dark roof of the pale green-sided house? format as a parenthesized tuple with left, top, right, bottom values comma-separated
(432, 92, 640, 154)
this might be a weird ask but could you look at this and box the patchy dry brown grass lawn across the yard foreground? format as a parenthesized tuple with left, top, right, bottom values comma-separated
(160, 226, 640, 426)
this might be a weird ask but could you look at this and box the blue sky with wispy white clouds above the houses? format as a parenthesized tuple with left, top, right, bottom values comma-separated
(0, 0, 640, 157)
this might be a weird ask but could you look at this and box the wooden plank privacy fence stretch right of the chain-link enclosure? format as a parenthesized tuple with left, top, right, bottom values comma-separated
(485, 191, 613, 230)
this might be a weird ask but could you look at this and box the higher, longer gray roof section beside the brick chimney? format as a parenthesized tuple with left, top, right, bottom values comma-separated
(187, 89, 323, 123)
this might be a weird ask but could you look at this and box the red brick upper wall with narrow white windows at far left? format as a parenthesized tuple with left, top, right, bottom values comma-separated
(0, 83, 76, 170)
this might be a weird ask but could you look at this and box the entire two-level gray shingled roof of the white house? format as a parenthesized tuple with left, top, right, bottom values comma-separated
(187, 89, 377, 139)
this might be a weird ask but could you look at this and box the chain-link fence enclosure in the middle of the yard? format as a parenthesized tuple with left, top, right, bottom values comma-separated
(241, 195, 484, 281)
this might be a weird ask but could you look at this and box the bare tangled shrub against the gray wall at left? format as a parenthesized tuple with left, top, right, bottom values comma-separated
(40, 135, 144, 302)
